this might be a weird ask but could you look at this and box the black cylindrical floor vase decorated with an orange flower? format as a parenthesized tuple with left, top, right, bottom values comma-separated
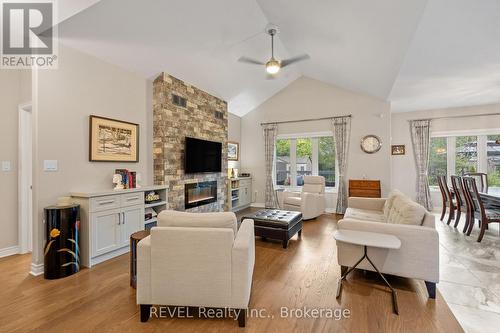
(44, 205, 80, 279)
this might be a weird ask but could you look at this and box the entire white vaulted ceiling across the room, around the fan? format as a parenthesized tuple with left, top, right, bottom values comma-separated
(55, 0, 500, 115)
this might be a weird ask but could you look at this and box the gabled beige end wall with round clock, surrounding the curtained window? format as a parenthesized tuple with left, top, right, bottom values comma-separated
(241, 77, 391, 208)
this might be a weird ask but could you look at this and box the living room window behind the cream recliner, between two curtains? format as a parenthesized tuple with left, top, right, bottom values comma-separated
(275, 134, 336, 187)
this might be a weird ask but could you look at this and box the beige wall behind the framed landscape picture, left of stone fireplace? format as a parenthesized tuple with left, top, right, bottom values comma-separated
(33, 45, 153, 263)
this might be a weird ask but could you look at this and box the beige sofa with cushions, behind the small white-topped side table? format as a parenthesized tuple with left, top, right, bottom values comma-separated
(337, 191, 439, 298)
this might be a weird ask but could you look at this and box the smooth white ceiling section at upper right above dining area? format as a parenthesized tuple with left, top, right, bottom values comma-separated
(389, 0, 500, 112)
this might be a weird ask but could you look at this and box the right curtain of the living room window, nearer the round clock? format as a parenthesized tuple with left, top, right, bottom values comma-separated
(333, 116, 351, 214)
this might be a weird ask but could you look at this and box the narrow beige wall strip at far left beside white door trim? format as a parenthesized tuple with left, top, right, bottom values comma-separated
(0, 70, 31, 256)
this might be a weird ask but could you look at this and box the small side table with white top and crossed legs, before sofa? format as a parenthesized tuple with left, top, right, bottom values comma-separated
(333, 230, 401, 314)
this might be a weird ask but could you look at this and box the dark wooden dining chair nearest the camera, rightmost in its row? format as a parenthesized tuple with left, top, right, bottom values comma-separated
(463, 177, 500, 242)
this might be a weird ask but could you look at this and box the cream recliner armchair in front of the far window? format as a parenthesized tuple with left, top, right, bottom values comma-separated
(283, 176, 325, 220)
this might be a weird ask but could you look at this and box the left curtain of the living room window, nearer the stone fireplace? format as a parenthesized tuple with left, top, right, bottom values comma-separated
(262, 124, 278, 208)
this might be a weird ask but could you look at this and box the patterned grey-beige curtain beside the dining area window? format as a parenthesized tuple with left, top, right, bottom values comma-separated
(410, 119, 432, 210)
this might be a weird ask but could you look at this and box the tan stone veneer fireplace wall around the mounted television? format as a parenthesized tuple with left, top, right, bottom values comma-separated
(153, 73, 228, 212)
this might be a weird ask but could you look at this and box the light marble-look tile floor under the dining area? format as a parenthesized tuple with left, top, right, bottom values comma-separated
(436, 215, 500, 333)
